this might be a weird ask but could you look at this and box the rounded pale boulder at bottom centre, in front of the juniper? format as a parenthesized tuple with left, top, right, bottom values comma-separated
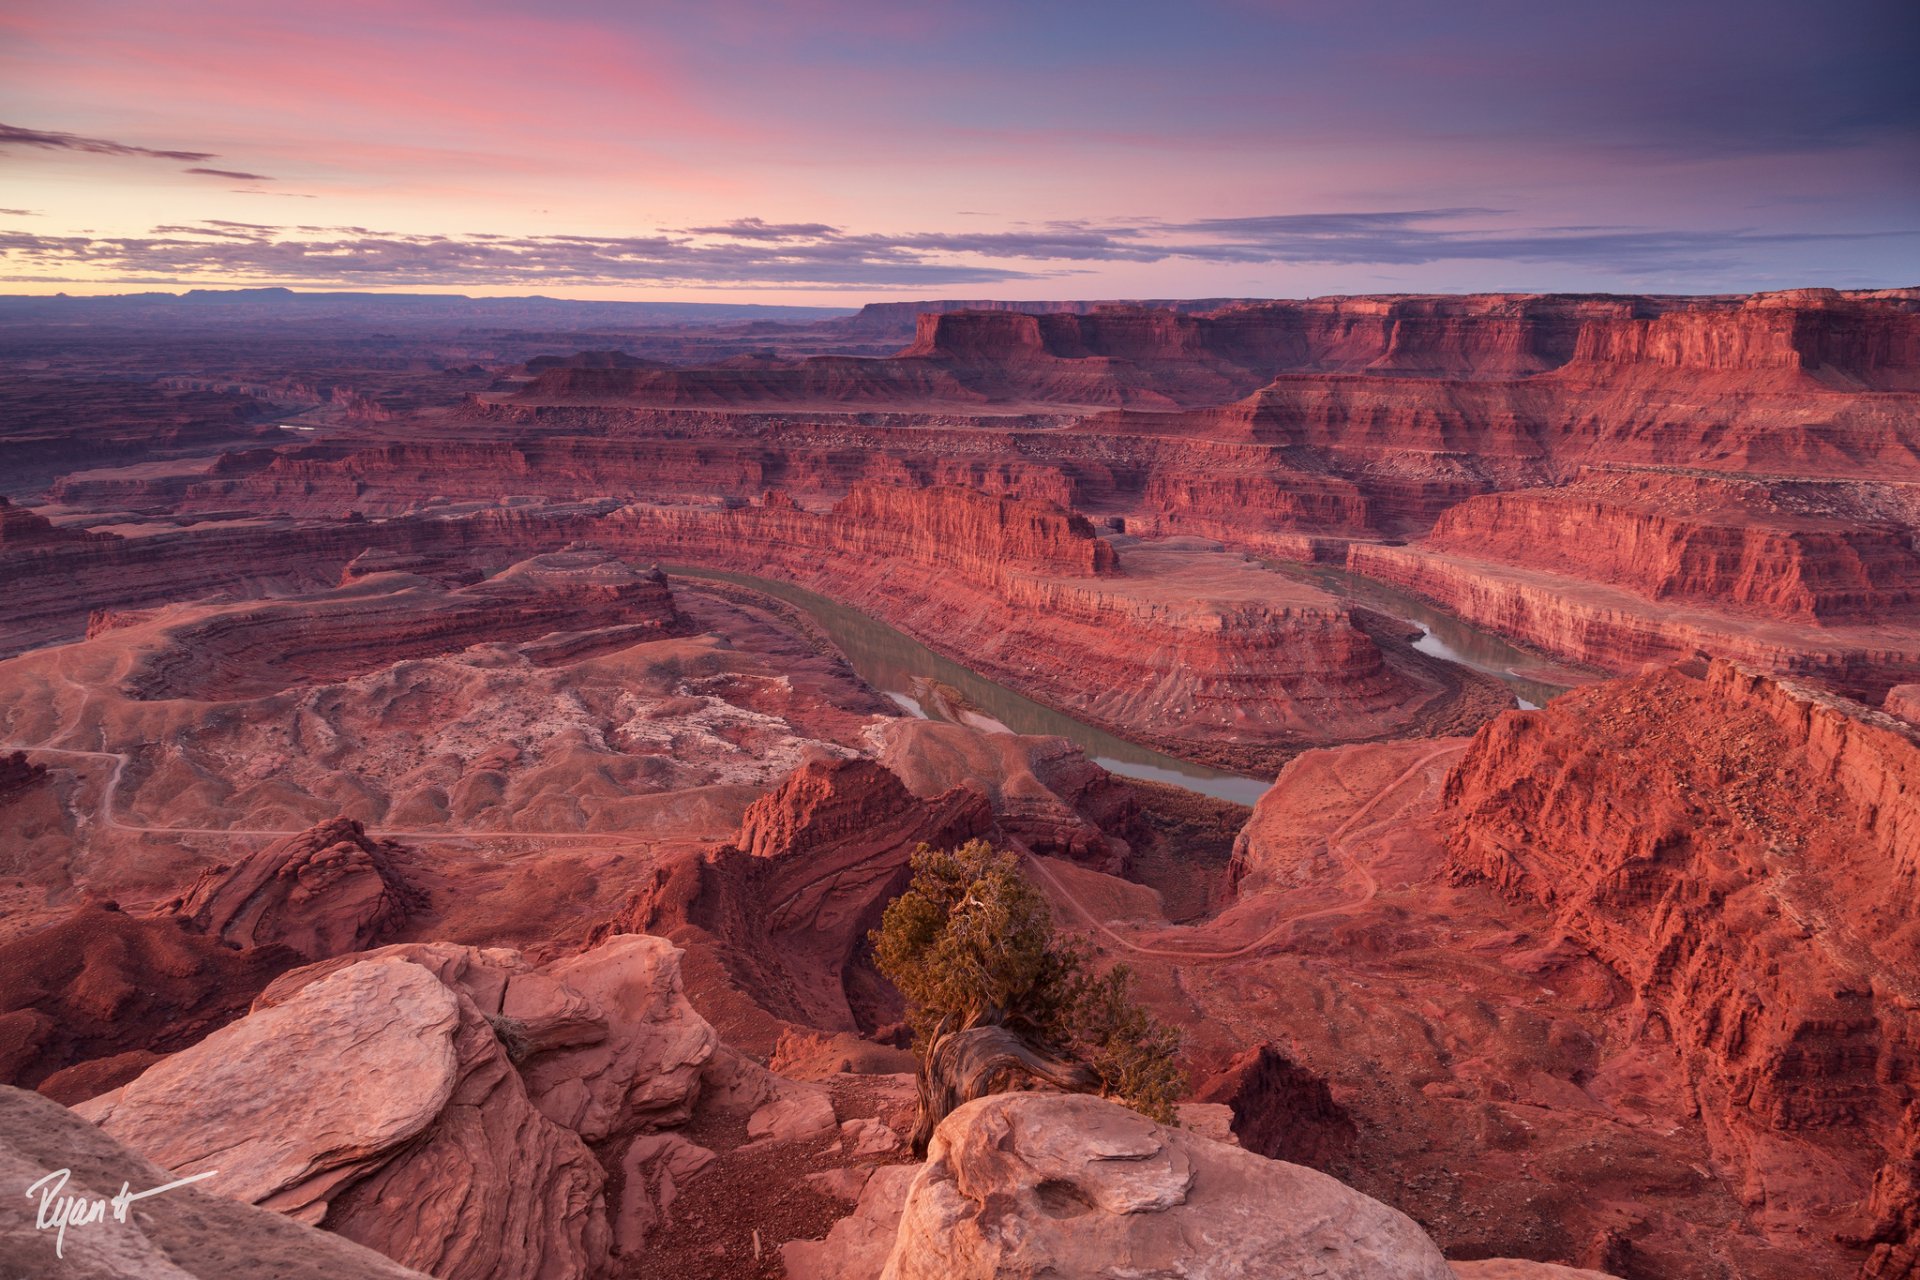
(883, 1094, 1452, 1280)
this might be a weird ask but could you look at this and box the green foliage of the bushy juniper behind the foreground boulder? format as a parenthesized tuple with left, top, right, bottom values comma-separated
(872, 841, 1187, 1121)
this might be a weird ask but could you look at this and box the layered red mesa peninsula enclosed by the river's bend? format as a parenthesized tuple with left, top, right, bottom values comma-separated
(601, 489, 1442, 758)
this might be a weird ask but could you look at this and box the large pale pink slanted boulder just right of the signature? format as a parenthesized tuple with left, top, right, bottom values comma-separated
(79, 960, 609, 1280)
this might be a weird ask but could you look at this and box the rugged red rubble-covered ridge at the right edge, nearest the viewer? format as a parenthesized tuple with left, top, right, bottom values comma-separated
(1448, 662, 1920, 1266)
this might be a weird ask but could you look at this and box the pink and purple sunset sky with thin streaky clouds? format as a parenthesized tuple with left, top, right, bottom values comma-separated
(0, 0, 1920, 305)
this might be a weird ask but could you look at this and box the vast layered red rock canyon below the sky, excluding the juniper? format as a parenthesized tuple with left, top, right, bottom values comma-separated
(0, 290, 1920, 1280)
